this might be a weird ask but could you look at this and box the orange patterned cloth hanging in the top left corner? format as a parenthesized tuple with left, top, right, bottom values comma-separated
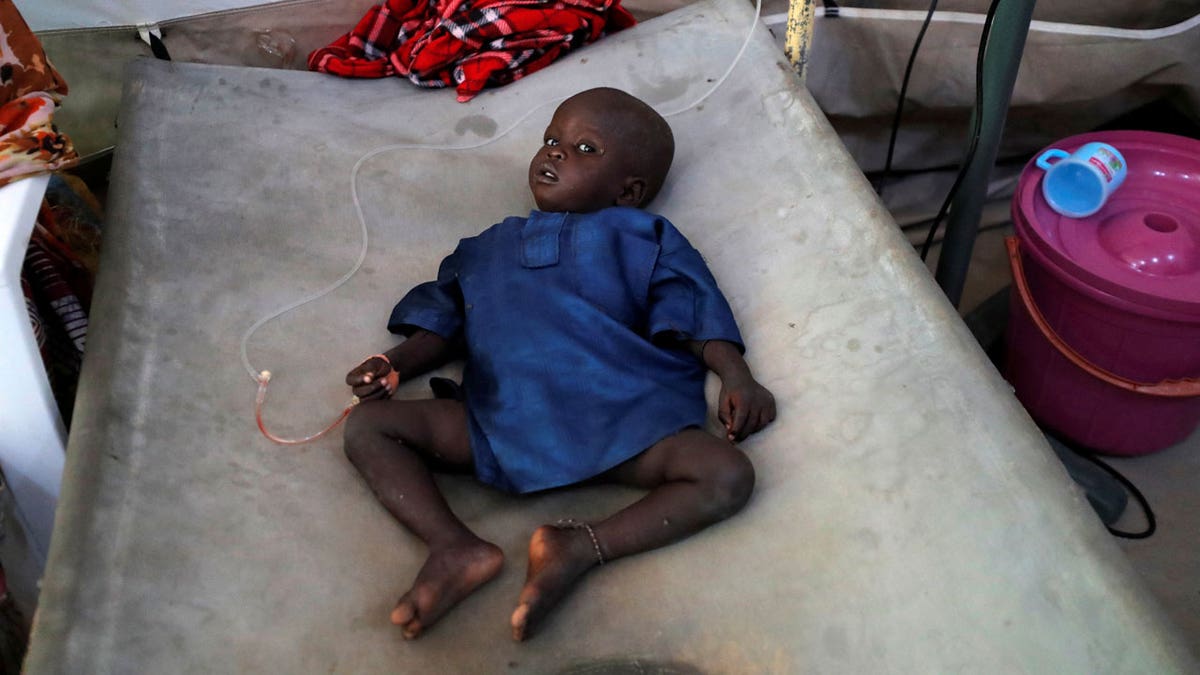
(0, 0, 77, 186)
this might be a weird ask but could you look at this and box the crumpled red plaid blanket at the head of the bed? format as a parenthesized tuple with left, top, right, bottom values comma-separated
(308, 0, 636, 101)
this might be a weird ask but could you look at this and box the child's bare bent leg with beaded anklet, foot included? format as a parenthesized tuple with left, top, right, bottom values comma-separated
(511, 429, 754, 640)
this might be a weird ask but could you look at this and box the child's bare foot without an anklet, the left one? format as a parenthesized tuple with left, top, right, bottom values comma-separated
(391, 539, 504, 640)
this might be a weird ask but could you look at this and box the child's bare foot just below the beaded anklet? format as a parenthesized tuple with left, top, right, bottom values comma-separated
(511, 525, 598, 640)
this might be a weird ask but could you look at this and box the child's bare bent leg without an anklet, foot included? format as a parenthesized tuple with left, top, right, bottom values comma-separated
(346, 400, 504, 639)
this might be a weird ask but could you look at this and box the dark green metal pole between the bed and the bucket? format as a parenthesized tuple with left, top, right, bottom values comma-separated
(935, 0, 1037, 306)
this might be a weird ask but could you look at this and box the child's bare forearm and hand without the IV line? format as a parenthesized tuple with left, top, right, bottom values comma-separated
(688, 340, 775, 441)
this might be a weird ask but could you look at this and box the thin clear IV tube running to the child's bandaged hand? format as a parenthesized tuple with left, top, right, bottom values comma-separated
(240, 0, 762, 446)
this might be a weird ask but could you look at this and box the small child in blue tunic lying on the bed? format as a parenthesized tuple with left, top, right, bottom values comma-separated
(346, 89, 775, 640)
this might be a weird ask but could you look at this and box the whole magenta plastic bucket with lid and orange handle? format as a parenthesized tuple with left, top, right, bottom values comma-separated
(1006, 131, 1200, 455)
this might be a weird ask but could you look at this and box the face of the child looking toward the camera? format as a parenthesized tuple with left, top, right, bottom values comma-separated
(529, 101, 641, 213)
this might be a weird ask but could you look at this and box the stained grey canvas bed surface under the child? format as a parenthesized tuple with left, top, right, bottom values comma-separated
(26, 1, 1196, 674)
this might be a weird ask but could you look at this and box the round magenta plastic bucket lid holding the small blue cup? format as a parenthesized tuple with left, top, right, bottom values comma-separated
(1013, 131, 1200, 319)
